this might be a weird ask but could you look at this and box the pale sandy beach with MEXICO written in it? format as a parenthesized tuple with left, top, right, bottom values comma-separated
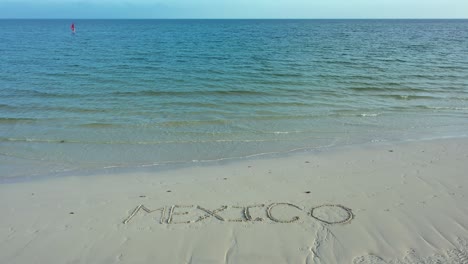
(0, 138, 468, 264)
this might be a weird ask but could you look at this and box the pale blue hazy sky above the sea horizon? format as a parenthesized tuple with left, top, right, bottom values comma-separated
(0, 0, 468, 19)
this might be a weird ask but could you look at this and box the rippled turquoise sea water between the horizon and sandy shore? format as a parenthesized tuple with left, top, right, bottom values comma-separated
(0, 20, 468, 177)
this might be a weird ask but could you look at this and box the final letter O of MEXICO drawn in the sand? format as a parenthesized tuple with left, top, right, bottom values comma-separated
(310, 204, 354, 225)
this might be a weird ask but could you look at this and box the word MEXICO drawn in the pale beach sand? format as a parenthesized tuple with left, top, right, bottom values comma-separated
(123, 203, 354, 225)
